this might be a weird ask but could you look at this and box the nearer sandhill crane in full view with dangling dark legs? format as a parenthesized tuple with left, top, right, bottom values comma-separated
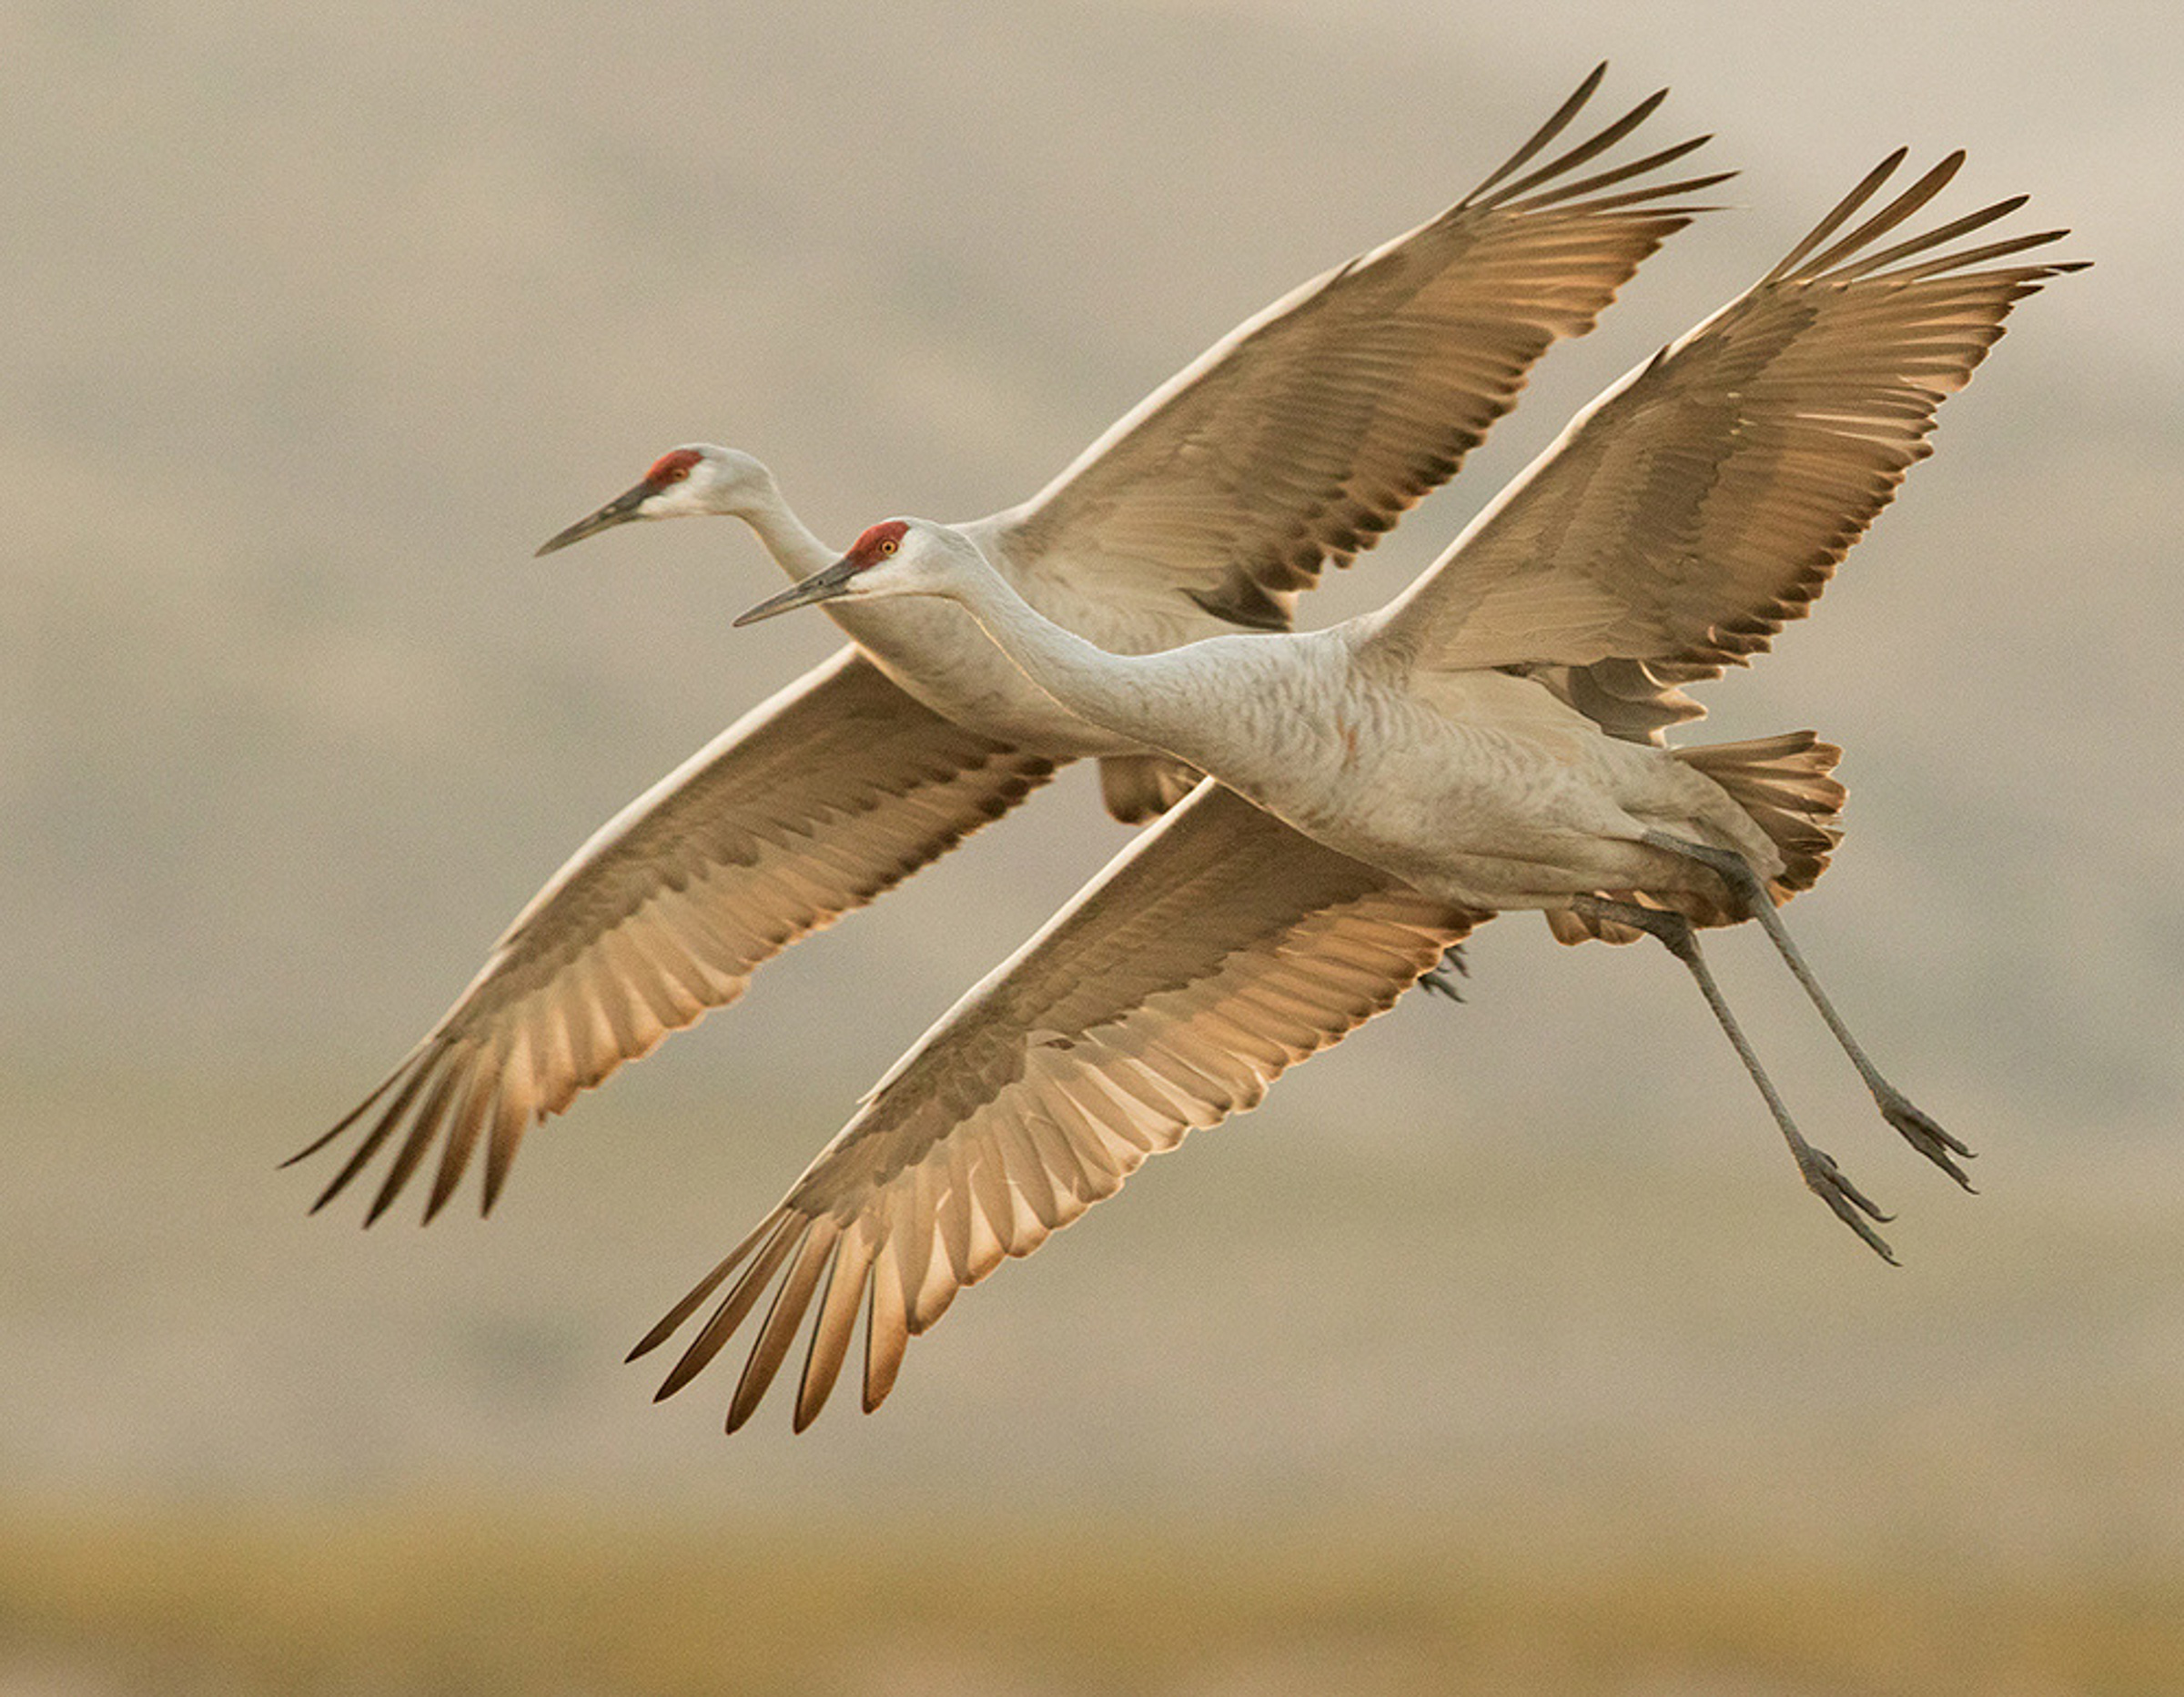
(633, 153, 2077, 1430)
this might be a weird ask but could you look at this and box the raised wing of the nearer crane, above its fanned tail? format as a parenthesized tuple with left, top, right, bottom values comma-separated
(1367, 151, 2079, 694)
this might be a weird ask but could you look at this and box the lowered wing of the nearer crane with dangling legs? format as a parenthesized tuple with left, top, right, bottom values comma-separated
(632, 784, 1474, 1430)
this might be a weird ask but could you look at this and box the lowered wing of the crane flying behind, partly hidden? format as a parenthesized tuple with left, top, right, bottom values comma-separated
(295, 649, 1055, 1223)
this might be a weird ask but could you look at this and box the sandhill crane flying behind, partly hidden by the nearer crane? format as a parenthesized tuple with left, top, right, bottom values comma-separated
(295, 66, 1727, 1223)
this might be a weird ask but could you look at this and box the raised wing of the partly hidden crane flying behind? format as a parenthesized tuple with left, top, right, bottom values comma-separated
(987, 66, 1730, 629)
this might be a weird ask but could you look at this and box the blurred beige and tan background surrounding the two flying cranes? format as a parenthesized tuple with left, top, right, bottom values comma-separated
(0, 0, 2184, 1697)
